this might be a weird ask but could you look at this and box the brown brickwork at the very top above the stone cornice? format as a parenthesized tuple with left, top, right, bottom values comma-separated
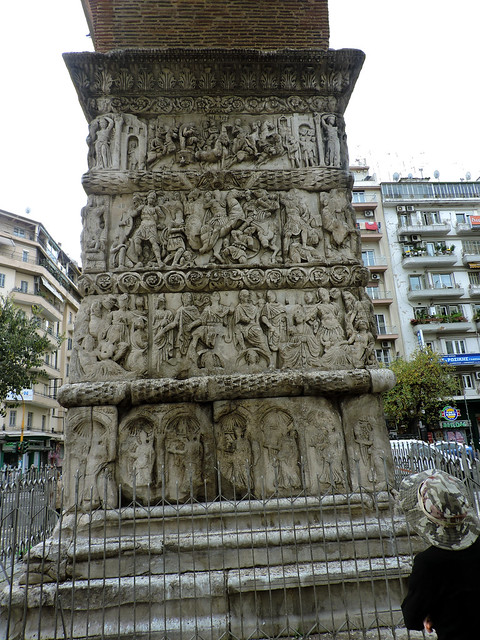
(82, 0, 329, 53)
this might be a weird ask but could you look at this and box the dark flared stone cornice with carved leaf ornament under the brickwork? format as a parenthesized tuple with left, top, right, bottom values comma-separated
(64, 49, 365, 119)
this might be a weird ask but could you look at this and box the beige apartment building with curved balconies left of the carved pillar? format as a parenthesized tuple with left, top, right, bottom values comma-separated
(0, 210, 80, 468)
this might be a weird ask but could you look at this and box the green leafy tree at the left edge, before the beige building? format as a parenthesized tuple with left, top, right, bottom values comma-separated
(0, 298, 58, 415)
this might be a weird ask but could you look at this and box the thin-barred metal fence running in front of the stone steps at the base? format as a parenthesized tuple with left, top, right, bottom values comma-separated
(0, 447, 480, 640)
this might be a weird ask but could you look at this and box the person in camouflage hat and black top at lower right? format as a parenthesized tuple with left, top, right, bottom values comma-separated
(399, 470, 480, 640)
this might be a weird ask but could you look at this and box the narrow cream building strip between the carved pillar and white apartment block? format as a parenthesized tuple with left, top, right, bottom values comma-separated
(350, 163, 403, 365)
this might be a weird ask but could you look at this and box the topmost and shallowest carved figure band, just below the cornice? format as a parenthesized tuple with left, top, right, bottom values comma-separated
(87, 113, 348, 171)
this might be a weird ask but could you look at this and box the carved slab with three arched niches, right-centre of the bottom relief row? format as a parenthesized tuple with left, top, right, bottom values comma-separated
(213, 398, 349, 497)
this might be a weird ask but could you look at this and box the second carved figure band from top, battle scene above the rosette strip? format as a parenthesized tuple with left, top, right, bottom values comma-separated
(99, 189, 359, 272)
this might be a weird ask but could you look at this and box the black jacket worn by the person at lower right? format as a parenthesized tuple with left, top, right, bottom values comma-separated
(402, 538, 480, 640)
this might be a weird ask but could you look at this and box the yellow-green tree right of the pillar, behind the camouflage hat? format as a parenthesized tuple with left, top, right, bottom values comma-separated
(384, 349, 459, 435)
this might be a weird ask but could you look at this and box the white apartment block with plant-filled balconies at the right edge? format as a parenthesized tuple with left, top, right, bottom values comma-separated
(382, 178, 480, 439)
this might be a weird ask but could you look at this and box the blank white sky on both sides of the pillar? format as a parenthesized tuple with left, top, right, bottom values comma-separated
(0, 0, 480, 260)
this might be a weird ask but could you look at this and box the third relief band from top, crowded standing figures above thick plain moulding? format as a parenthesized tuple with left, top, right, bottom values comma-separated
(71, 287, 375, 381)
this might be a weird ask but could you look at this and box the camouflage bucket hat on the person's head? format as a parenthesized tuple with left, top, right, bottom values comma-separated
(399, 470, 480, 551)
